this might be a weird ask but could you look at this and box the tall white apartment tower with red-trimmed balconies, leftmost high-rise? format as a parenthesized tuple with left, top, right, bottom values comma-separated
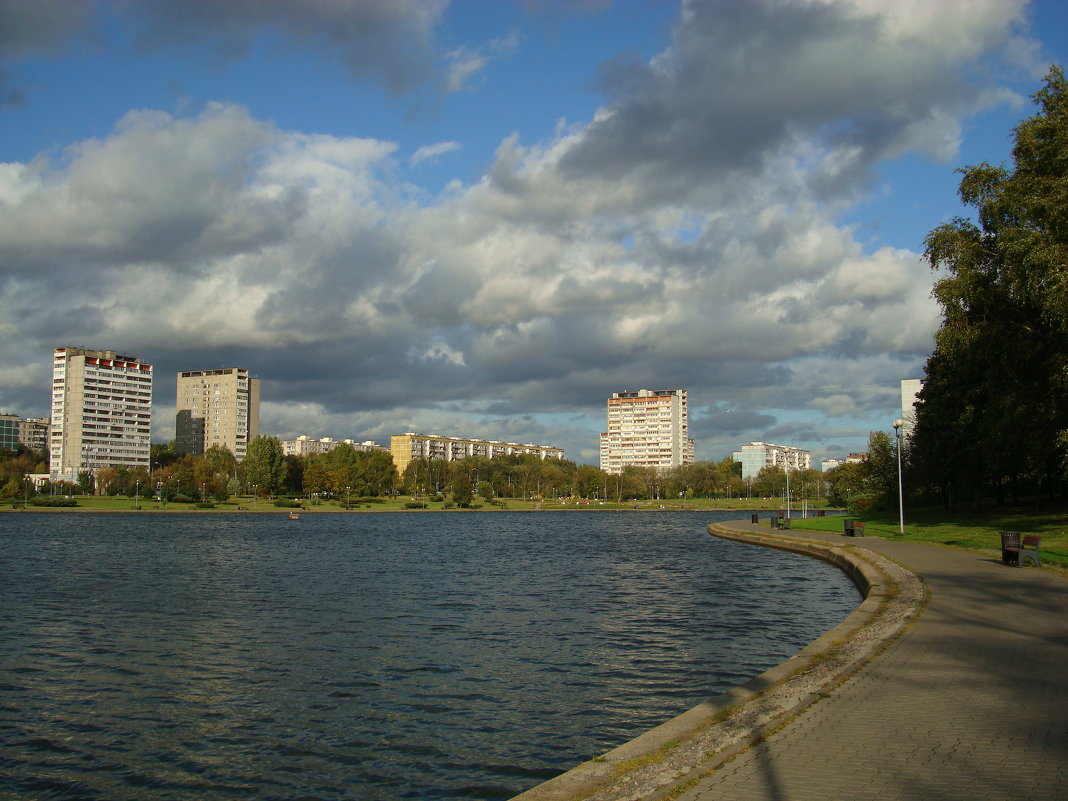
(49, 347, 152, 481)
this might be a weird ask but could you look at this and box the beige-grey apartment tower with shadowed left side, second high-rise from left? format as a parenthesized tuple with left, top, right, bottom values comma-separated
(174, 367, 260, 459)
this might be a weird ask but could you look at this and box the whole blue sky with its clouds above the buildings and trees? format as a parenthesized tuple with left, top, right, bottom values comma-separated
(0, 0, 1068, 464)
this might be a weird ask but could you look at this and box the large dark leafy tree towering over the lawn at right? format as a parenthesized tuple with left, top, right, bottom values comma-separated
(912, 67, 1068, 508)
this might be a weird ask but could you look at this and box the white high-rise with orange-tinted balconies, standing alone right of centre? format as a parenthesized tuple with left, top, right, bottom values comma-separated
(600, 390, 694, 473)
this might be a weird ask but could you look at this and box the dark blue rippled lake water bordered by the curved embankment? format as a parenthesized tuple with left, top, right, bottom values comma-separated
(0, 512, 859, 801)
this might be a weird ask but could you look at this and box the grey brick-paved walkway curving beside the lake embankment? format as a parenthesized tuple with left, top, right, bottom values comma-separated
(675, 524, 1068, 801)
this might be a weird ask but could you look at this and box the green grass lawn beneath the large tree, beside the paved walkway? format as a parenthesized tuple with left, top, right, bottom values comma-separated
(791, 503, 1068, 566)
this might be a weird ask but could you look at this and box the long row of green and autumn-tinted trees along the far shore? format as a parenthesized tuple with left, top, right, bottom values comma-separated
(0, 436, 829, 506)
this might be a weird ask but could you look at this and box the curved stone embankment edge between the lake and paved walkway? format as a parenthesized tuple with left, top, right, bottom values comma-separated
(513, 522, 926, 801)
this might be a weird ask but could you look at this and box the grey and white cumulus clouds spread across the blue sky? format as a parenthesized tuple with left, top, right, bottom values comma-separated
(0, 0, 1042, 458)
